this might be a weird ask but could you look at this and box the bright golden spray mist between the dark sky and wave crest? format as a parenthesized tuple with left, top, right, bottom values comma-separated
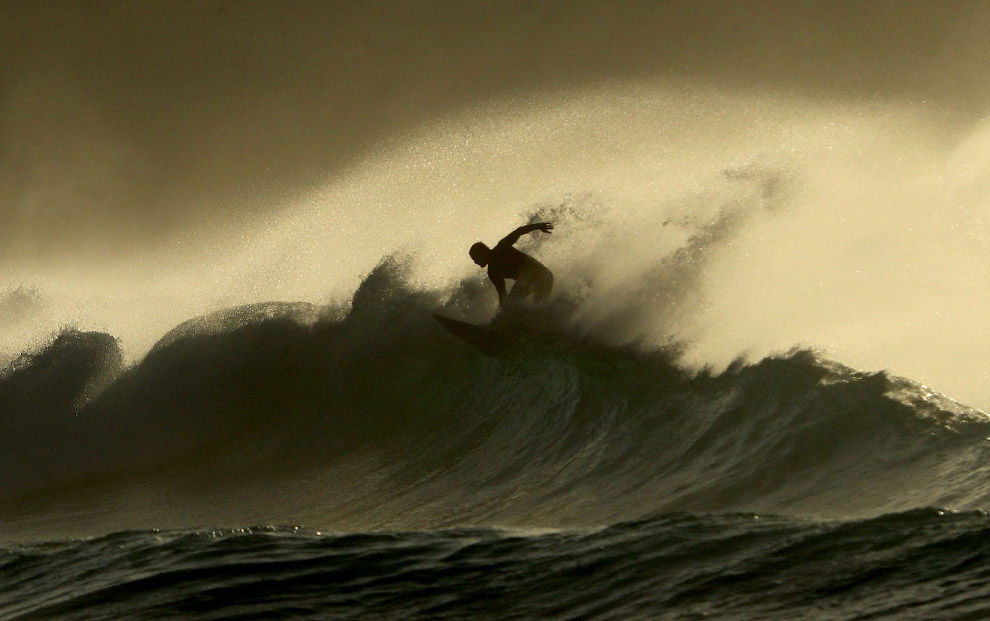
(0, 80, 990, 406)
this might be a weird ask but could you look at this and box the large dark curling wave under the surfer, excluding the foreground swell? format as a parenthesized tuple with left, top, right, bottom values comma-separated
(0, 260, 990, 533)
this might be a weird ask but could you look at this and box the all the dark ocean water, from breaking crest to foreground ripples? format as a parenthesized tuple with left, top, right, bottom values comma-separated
(0, 260, 990, 619)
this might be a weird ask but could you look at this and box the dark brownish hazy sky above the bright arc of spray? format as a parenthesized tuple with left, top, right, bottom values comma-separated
(0, 0, 990, 258)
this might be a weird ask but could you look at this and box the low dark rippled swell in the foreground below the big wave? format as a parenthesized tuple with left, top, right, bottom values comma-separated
(0, 509, 990, 619)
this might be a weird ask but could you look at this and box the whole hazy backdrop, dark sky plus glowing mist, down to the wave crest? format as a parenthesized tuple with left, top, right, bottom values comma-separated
(0, 0, 990, 406)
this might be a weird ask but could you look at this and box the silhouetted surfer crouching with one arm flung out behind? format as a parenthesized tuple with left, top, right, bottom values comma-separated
(468, 222, 553, 306)
